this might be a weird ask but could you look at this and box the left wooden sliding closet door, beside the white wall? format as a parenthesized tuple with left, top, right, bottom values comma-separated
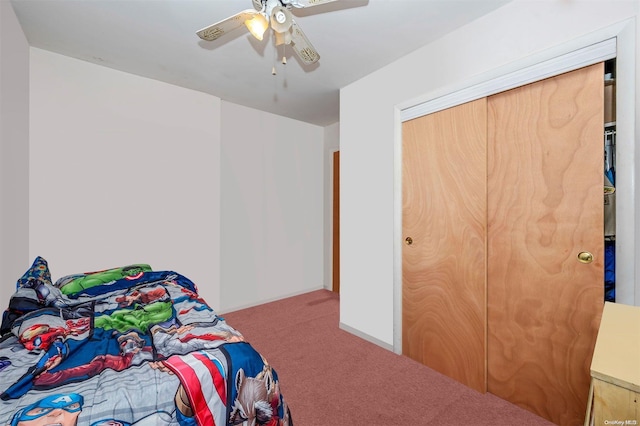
(402, 99, 486, 392)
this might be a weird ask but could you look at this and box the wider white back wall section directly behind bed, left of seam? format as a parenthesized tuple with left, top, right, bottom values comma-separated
(27, 48, 221, 308)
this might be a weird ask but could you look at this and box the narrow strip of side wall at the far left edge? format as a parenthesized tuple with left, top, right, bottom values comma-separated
(0, 1, 30, 309)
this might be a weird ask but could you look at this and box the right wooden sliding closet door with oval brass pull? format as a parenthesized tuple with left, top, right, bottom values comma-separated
(487, 64, 604, 425)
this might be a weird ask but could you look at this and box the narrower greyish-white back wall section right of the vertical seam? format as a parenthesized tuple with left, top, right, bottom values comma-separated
(221, 102, 324, 311)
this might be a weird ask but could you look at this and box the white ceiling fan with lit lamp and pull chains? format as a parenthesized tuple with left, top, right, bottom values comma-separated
(196, 0, 336, 64)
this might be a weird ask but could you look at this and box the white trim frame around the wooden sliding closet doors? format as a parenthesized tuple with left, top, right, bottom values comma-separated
(393, 19, 640, 354)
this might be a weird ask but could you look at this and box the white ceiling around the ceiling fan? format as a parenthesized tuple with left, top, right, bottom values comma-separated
(8, 0, 511, 126)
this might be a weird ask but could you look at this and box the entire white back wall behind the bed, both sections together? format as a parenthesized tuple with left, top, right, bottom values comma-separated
(8, 42, 330, 312)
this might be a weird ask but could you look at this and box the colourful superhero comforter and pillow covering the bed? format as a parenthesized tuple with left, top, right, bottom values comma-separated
(0, 257, 293, 426)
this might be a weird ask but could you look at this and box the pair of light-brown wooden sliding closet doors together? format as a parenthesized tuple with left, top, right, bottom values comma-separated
(402, 63, 604, 425)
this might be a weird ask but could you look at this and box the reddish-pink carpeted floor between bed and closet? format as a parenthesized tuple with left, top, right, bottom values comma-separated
(222, 290, 552, 426)
